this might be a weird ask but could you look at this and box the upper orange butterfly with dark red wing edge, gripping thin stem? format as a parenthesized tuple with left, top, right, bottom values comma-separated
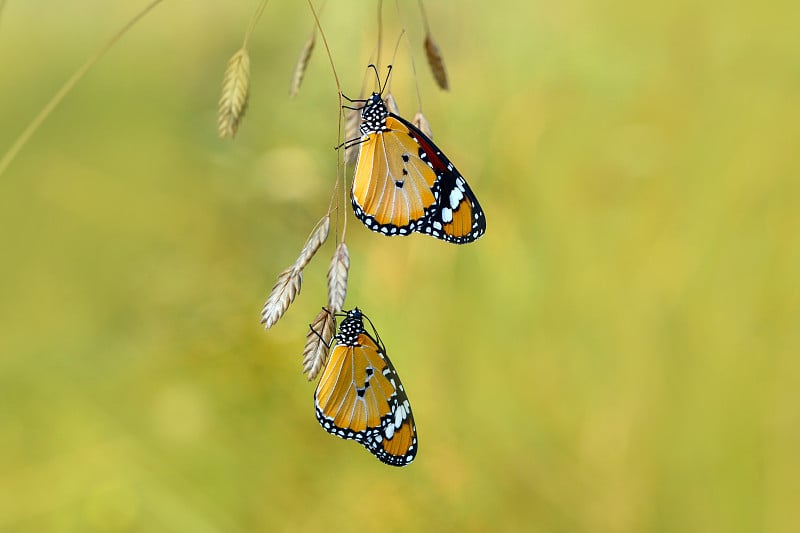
(345, 65, 486, 244)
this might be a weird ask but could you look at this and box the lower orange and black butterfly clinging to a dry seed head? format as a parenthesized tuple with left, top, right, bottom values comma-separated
(314, 308, 417, 466)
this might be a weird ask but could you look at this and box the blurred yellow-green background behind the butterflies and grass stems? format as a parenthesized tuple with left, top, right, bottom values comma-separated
(0, 0, 800, 532)
